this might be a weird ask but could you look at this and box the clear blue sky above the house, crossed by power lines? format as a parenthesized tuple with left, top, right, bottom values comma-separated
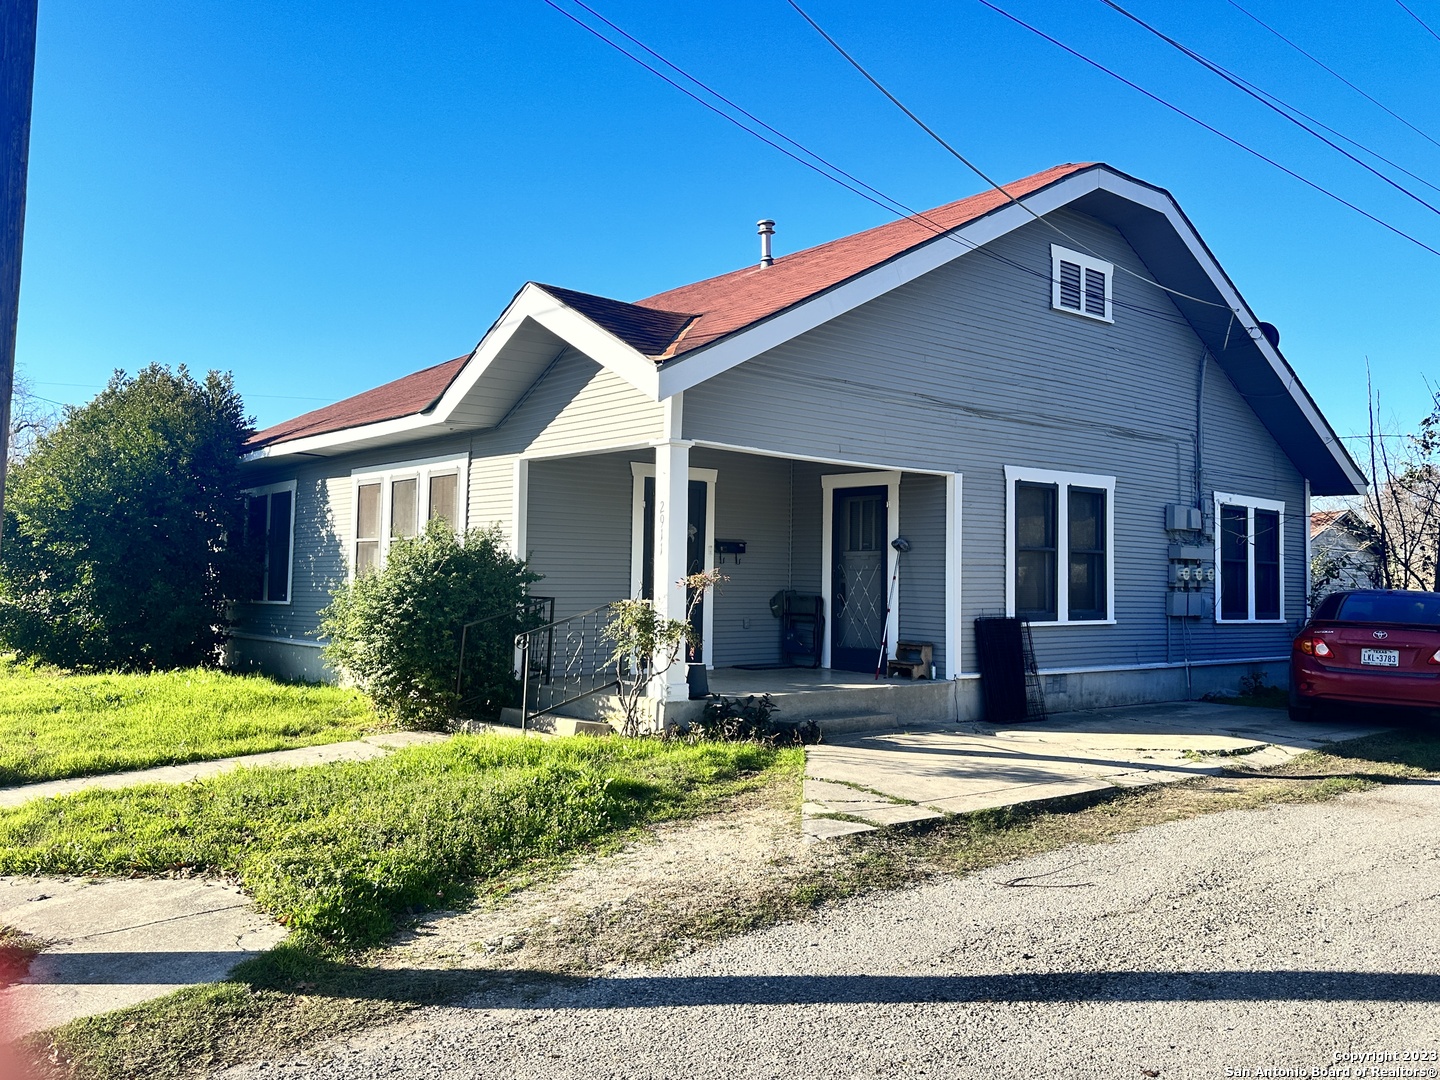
(17, 0, 1440, 449)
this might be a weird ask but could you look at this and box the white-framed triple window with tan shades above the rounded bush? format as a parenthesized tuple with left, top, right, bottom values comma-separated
(350, 456, 469, 575)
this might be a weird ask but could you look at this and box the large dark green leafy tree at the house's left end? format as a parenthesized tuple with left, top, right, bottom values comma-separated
(0, 364, 251, 668)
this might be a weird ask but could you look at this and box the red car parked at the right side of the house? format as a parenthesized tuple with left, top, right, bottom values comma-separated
(1290, 589, 1440, 720)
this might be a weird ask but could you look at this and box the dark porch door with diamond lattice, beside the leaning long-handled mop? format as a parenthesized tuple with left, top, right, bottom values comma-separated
(829, 487, 890, 671)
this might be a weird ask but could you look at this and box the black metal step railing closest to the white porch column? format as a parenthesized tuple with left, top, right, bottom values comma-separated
(516, 603, 622, 729)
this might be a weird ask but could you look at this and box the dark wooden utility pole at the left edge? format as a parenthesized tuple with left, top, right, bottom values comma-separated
(0, 0, 39, 552)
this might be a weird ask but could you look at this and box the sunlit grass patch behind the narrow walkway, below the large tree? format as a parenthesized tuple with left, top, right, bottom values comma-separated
(0, 658, 380, 788)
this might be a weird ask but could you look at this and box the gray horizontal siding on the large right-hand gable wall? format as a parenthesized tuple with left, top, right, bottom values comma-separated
(684, 213, 1305, 671)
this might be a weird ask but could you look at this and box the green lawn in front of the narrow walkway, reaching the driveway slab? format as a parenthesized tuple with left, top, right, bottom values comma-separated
(0, 736, 804, 946)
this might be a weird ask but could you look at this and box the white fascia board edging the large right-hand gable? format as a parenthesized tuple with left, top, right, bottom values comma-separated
(660, 168, 1367, 491)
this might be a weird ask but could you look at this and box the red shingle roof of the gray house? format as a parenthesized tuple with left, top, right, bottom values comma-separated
(245, 163, 1092, 451)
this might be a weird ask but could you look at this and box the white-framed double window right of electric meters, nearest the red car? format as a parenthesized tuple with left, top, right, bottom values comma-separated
(1215, 491, 1284, 622)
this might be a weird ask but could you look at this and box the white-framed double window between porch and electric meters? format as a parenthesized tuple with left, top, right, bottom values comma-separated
(1005, 467, 1115, 624)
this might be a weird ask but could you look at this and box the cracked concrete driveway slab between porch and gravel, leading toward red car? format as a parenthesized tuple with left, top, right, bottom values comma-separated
(804, 701, 1382, 840)
